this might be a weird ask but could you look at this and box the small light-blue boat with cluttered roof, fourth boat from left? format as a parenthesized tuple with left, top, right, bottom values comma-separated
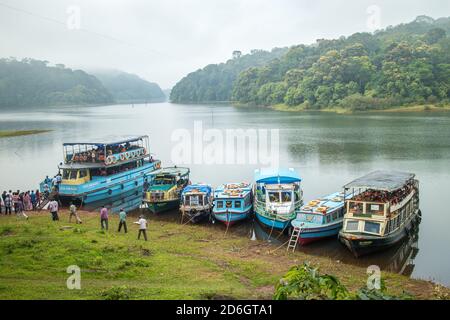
(212, 182, 253, 226)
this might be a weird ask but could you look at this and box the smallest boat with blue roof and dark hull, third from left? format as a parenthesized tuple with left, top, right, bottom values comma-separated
(180, 184, 213, 223)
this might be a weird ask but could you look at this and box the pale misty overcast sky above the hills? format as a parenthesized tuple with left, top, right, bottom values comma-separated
(0, 0, 450, 88)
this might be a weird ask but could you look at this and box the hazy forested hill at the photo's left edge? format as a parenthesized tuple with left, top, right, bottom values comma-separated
(0, 59, 114, 107)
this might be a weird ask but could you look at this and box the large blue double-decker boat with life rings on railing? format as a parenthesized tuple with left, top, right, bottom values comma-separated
(40, 136, 161, 204)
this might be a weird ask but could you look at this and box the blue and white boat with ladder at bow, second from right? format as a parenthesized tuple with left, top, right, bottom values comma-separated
(291, 192, 352, 245)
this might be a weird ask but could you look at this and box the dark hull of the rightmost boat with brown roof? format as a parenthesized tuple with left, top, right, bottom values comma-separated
(339, 212, 421, 258)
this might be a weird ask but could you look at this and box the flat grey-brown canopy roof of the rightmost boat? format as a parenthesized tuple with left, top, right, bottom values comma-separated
(344, 170, 415, 192)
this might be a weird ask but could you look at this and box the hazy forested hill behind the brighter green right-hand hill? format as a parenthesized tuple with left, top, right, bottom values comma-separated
(170, 48, 287, 103)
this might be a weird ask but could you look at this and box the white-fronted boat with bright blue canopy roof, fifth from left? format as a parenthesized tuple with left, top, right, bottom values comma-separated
(254, 168, 303, 231)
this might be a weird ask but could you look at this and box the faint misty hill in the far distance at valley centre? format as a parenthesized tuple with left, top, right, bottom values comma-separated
(93, 70, 166, 102)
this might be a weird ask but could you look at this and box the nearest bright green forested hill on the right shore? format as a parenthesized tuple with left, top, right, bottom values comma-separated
(232, 16, 450, 110)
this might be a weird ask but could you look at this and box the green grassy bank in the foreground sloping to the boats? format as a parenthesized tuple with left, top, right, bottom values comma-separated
(0, 212, 448, 299)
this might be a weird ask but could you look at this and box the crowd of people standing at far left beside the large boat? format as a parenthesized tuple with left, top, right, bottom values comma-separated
(0, 190, 42, 219)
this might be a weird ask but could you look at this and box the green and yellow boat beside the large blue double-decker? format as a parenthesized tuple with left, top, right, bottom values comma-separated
(144, 167, 190, 213)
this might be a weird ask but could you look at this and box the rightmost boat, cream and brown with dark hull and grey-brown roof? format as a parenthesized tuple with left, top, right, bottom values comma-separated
(339, 171, 421, 257)
